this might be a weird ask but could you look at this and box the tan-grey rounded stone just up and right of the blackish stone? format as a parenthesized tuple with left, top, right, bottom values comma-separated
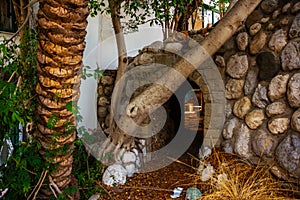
(269, 29, 287, 53)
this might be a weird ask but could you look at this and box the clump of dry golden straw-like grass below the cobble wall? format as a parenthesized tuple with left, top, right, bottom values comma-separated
(178, 150, 296, 200)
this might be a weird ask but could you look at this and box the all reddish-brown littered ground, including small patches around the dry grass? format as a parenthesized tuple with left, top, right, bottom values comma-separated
(100, 149, 300, 200)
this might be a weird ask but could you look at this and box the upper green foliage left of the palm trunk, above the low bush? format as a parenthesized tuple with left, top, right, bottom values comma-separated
(0, 29, 37, 141)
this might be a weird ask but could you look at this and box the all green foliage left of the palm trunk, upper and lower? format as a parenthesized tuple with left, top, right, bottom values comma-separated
(0, 29, 42, 199)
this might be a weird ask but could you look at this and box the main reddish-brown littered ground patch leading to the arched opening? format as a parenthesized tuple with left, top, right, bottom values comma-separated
(100, 154, 204, 200)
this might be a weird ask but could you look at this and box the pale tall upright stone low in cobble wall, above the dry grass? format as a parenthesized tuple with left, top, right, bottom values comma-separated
(234, 124, 250, 158)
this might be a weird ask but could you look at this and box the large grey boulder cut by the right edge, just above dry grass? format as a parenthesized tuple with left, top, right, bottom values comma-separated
(276, 133, 300, 178)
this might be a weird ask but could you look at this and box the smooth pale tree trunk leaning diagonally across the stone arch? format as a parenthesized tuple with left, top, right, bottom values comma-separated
(99, 0, 261, 159)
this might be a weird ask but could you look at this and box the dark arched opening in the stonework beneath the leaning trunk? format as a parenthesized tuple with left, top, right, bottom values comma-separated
(166, 80, 205, 157)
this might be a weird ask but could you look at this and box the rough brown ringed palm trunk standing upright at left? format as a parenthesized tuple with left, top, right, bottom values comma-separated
(35, 0, 89, 197)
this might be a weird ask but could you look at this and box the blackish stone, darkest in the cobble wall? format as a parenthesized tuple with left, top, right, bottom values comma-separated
(256, 52, 280, 81)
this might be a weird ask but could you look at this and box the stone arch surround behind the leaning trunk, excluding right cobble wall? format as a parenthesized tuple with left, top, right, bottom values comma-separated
(98, 32, 225, 150)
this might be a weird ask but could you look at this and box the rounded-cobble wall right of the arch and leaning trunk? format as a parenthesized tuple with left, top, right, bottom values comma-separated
(215, 0, 300, 179)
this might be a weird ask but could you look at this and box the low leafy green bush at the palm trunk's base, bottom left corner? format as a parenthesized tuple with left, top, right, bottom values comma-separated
(0, 141, 47, 199)
